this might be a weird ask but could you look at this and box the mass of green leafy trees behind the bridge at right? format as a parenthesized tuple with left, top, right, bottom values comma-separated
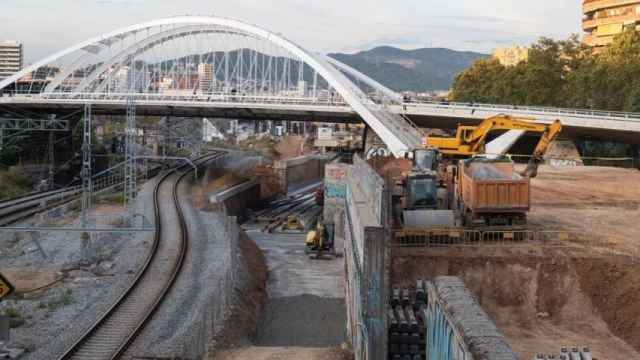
(451, 29, 640, 111)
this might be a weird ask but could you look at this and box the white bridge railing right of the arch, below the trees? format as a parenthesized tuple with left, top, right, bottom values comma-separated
(402, 101, 640, 120)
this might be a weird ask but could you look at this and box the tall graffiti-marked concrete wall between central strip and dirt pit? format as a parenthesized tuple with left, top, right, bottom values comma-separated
(344, 156, 390, 360)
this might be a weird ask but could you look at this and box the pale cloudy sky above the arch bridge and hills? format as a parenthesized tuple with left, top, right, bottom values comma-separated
(0, 0, 581, 63)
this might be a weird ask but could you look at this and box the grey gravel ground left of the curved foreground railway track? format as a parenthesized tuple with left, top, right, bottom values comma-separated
(0, 180, 155, 360)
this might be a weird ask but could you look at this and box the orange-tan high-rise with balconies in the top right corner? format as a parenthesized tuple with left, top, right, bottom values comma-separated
(582, 0, 640, 51)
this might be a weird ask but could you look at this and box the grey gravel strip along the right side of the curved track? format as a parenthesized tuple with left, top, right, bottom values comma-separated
(125, 174, 247, 358)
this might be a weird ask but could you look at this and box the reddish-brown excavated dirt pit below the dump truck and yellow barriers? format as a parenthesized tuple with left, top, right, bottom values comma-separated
(392, 247, 640, 360)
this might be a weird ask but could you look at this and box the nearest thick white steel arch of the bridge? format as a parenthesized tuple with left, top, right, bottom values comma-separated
(0, 16, 421, 156)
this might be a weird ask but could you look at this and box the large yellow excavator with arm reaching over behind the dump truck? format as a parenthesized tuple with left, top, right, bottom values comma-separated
(424, 114, 562, 178)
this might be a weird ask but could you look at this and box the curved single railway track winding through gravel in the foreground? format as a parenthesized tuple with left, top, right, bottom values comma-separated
(59, 152, 223, 360)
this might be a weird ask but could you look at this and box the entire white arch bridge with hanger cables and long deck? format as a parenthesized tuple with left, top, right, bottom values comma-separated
(0, 16, 640, 149)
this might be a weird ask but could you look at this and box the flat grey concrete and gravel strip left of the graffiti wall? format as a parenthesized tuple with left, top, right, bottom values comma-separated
(244, 224, 347, 347)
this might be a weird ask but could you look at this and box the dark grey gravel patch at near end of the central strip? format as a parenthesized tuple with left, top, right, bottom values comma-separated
(256, 295, 346, 347)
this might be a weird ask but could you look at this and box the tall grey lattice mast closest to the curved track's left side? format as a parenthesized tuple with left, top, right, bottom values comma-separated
(124, 97, 137, 221)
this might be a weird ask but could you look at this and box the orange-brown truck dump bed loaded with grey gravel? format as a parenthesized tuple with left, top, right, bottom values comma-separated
(459, 158, 530, 213)
